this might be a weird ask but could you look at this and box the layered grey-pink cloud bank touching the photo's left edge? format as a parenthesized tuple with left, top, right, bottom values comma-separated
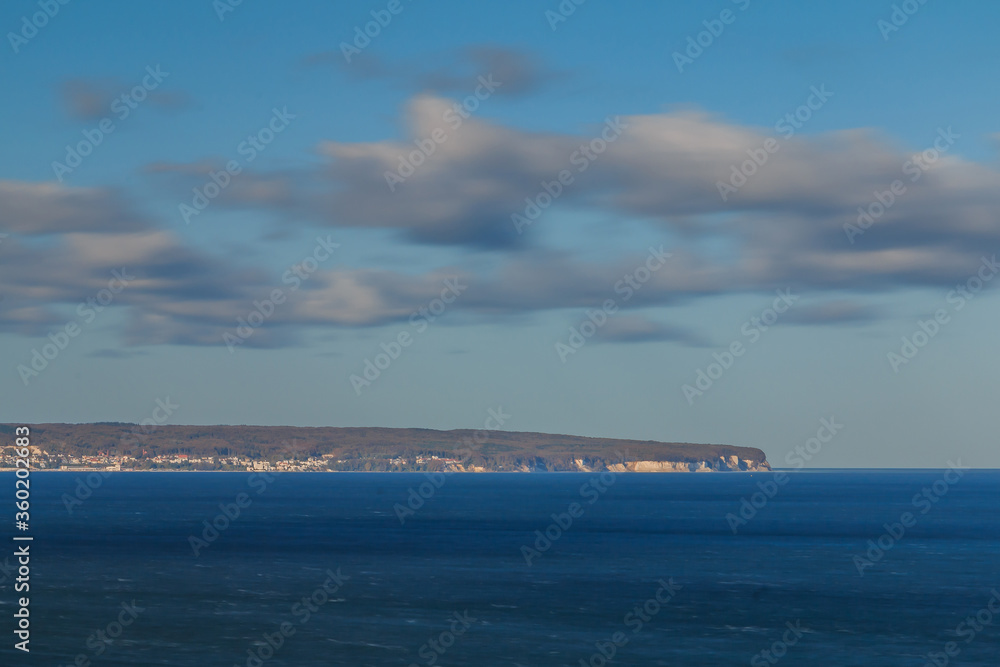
(0, 181, 270, 343)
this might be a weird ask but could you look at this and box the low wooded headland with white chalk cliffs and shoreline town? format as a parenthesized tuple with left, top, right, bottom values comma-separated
(0, 422, 771, 472)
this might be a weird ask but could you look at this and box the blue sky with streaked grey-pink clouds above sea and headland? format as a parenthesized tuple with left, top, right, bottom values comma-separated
(0, 0, 1000, 468)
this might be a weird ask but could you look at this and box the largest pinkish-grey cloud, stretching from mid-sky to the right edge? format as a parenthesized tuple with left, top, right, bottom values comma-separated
(298, 96, 1000, 289)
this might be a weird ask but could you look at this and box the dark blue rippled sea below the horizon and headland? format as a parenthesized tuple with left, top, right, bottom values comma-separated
(0, 471, 1000, 667)
